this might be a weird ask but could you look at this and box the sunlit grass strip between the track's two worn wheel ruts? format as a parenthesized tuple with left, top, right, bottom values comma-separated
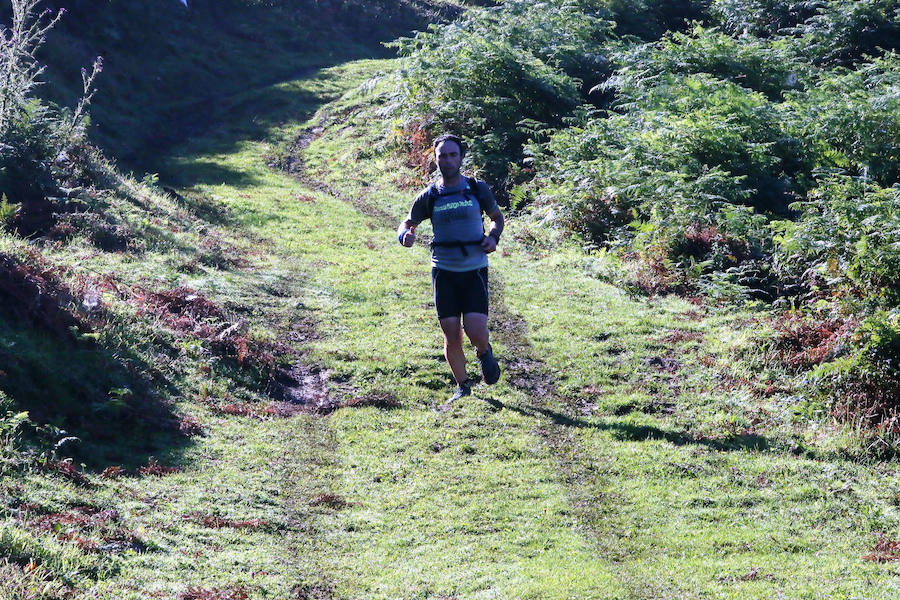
(149, 66, 614, 598)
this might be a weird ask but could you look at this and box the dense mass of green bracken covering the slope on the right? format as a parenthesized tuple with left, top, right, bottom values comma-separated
(390, 0, 900, 446)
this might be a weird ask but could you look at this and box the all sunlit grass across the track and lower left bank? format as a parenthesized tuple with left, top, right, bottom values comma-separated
(0, 5, 900, 599)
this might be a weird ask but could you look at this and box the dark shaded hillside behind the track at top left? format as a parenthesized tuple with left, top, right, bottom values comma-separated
(29, 0, 461, 166)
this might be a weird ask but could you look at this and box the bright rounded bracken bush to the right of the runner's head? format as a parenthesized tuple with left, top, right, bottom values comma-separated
(530, 75, 790, 245)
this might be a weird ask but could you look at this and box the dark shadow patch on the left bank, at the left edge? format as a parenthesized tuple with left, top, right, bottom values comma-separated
(0, 310, 190, 471)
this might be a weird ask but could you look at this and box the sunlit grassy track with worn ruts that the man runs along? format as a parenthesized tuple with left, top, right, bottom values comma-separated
(139, 56, 898, 599)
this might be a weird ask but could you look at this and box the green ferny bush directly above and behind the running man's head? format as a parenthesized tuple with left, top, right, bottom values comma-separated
(397, 0, 610, 187)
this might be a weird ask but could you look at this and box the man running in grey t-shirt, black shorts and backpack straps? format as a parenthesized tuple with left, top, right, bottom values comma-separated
(397, 135, 503, 400)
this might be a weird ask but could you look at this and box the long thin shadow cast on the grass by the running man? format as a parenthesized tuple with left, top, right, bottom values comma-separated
(483, 398, 772, 452)
